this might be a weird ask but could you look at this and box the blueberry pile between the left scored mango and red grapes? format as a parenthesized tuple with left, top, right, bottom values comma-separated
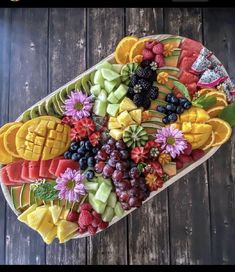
(64, 139, 99, 170)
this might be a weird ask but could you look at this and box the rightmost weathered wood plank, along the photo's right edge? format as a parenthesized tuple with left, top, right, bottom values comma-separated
(203, 8, 235, 264)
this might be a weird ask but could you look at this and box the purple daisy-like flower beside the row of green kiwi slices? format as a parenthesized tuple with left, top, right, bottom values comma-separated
(64, 91, 92, 120)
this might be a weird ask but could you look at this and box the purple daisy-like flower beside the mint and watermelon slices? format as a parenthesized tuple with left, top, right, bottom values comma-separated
(55, 168, 86, 202)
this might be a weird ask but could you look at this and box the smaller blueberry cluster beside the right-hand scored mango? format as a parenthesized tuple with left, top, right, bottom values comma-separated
(156, 93, 192, 124)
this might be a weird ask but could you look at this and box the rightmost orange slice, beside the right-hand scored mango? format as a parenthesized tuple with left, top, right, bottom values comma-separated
(207, 118, 232, 146)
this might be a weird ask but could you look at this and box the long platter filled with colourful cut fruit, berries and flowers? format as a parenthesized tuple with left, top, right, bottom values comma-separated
(0, 34, 235, 244)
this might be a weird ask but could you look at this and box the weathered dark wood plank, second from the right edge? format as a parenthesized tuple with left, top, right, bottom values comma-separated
(164, 8, 210, 264)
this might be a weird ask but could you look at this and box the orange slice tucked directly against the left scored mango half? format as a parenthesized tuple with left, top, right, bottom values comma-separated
(3, 122, 23, 158)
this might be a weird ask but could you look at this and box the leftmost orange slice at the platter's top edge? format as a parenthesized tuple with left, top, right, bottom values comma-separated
(115, 36, 138, 64)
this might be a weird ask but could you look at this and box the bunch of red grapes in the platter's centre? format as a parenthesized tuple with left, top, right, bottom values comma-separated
(95, 139, 150, 210)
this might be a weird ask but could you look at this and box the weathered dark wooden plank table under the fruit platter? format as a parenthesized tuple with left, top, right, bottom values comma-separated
(0, 8, 235, 264)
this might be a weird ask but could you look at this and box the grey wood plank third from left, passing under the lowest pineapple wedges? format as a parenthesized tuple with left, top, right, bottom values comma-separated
(46, 8, 86, 264)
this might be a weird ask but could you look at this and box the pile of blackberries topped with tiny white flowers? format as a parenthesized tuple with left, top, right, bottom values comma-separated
(127, 60, 159, 109)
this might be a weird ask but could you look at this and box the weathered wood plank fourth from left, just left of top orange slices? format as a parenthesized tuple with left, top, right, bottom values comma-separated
(87, 8, 127, 264)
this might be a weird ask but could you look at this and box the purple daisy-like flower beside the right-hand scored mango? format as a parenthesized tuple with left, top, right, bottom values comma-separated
(155, 126, 187, 159)
